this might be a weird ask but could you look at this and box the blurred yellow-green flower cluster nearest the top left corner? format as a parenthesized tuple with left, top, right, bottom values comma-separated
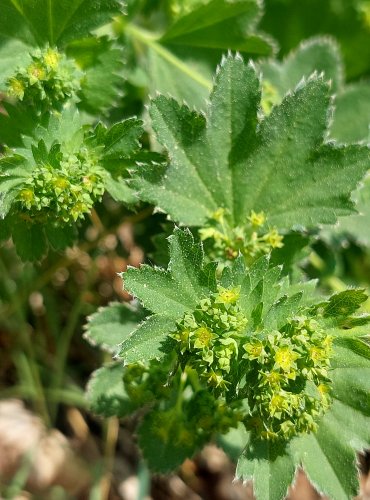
(7, 47, 80, 109)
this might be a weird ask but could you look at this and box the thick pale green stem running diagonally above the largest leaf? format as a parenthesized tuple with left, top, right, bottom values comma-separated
(124, 23, 212, 90)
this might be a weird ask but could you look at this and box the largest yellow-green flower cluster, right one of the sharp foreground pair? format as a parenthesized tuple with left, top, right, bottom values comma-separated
(243, 316, 332, 439)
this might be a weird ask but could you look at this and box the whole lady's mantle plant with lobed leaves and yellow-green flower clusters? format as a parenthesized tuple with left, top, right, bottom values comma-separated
(0, 0, 370, 500)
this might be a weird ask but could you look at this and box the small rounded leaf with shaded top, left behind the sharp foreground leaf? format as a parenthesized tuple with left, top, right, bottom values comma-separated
(84, 302, 144, 352)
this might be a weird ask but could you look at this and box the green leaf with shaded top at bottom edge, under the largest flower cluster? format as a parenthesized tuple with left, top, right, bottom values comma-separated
(236, 439, 295, 500)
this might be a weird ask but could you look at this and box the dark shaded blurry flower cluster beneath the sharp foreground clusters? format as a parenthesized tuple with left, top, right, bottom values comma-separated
(123, 360, 243, 444)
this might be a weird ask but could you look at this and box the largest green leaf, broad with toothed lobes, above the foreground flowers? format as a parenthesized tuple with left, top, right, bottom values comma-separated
(135, 56, 370, 229)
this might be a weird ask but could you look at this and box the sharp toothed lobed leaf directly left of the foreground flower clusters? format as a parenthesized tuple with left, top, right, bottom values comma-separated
(120, 229, 215, 363)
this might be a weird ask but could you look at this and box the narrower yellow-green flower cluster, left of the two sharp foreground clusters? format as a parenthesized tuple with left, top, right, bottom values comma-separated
(171, 286, 247, 391)
